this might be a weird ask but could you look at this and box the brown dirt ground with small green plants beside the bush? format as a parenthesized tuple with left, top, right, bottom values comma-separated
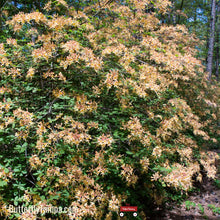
(151, 152, 220, 220)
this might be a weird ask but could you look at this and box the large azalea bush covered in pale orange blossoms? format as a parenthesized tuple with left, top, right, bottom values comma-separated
(0, 0, 220, 219)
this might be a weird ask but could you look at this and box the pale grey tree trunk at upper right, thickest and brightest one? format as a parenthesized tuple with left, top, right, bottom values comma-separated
(206, 0, 216, 81)
